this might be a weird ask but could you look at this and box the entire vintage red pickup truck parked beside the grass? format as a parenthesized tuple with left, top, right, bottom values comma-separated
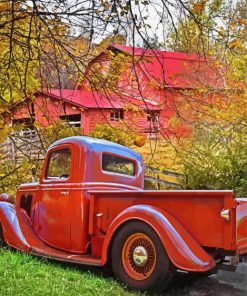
(0, 137, 247, 290)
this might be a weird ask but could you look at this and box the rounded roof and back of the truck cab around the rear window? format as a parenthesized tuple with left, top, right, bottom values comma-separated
(50, 136, 144, 189)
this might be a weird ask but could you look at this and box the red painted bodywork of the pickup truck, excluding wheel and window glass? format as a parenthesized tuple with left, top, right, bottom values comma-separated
(0, 137, 247, 288)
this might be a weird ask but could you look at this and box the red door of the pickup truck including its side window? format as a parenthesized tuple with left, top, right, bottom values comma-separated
(34, 145, 72, 250)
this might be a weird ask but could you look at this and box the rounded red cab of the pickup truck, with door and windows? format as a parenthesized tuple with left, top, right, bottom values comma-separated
(16, 137, 144, 253)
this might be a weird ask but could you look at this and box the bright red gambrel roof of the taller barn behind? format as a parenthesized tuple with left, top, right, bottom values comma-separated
(90, 44, 223, 89)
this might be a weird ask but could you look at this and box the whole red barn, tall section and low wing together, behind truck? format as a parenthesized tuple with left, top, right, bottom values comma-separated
(11, 44, 222, 137)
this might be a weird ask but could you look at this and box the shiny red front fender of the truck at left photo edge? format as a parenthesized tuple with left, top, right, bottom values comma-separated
(0, 202, 30, 252)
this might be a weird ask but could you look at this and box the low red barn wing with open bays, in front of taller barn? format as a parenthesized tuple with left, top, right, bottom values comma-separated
(11, 89, 160, 135)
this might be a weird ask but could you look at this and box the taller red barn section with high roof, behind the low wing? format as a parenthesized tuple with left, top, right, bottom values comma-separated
(76, 44, 224, 137)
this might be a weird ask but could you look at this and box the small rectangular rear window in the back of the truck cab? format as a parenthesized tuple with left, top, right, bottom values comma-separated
(102, 154, 135, 176)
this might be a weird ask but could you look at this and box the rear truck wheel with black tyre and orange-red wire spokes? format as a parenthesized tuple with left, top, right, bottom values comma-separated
(111, 222, 169, 291)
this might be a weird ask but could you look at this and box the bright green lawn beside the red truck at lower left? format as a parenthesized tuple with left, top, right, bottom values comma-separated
(0, 249, 143, 296)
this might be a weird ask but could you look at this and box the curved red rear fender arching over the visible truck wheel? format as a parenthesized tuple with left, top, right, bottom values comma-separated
(102, 205, 215, 272)
